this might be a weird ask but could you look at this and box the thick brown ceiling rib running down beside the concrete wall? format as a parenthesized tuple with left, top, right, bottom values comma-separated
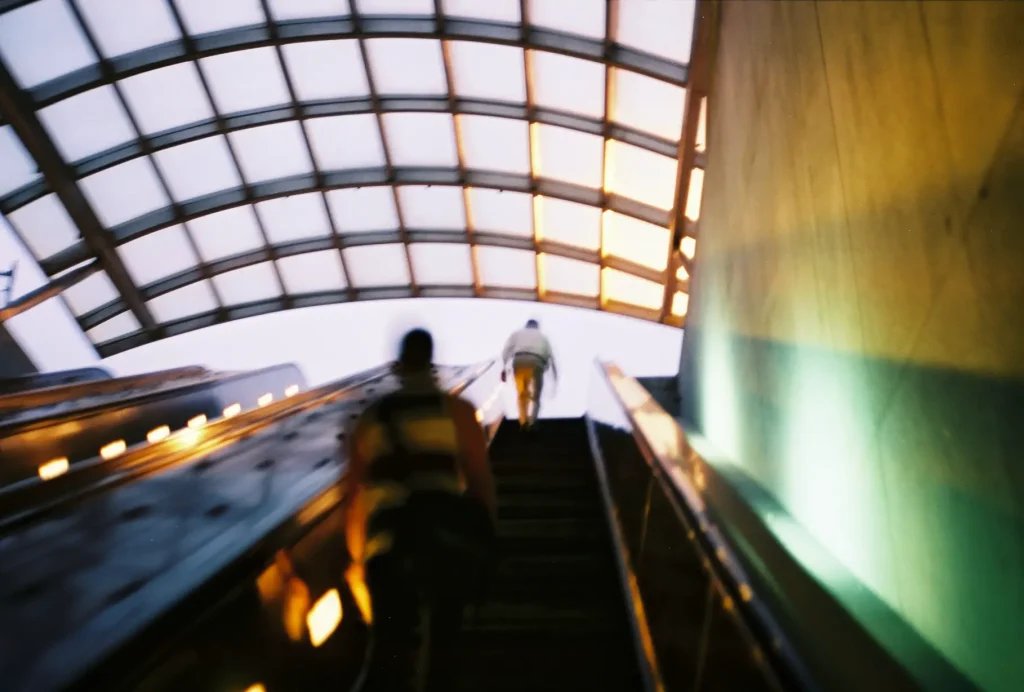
(659, 0, 716, 322)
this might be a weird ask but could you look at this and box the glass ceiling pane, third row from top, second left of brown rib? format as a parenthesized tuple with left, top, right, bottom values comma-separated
(532, 125, 604, 187)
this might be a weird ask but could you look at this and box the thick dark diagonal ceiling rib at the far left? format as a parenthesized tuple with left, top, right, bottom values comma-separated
(0, 61, 157, 337)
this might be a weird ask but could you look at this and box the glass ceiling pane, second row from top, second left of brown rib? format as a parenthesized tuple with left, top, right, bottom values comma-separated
(529, 50, 604, 118)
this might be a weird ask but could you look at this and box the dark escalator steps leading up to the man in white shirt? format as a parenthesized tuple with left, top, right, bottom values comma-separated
(459, 420, 643, 692)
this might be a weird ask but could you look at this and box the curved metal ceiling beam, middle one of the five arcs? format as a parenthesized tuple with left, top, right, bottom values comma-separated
(40, 167, 670, 275)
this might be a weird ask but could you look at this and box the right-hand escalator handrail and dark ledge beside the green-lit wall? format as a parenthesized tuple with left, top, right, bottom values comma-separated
(598, 362, 976, 691)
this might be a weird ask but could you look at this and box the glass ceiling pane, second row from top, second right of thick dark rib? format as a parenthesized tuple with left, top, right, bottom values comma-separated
(119, 62, 213, 134)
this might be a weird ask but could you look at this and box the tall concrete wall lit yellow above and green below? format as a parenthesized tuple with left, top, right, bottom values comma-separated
(680, 0, 1024, 691)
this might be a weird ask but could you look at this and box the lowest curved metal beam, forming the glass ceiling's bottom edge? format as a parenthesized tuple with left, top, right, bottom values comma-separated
(90, 286, 658, 358)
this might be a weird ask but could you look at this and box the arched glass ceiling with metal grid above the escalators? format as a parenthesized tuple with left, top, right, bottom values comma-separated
(0, 0, 703, 356)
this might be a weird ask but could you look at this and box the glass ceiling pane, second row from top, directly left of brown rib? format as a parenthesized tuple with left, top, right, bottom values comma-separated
(611, 70, 686, 141)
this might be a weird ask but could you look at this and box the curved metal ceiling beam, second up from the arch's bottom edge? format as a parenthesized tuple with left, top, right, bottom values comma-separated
(79, 229, 668, 332)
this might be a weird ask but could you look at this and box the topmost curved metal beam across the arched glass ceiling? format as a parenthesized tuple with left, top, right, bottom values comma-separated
(29, 14, 688, 107)
